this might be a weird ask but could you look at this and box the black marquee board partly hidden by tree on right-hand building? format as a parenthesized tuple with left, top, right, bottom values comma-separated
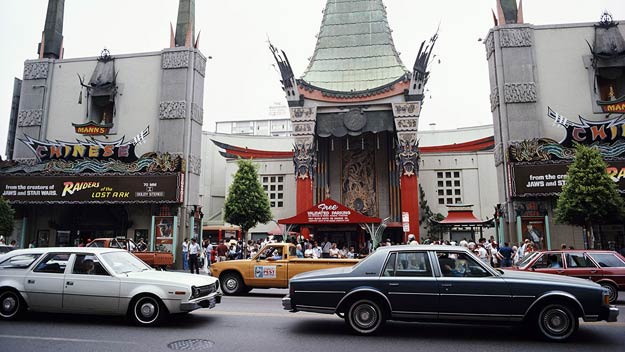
(510, 161, 625, 197)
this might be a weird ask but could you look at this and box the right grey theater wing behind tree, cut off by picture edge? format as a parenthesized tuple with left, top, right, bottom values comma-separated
(485, 1, 625, 250)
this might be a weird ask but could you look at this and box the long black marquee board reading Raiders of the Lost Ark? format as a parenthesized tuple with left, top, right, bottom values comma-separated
(0, 173, 183, 204)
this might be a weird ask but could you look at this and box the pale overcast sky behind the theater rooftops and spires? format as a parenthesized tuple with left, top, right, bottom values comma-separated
(0, 0, 625, 156)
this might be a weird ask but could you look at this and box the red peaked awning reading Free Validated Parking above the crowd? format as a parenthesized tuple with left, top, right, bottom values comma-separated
(278, 198, 382, 225)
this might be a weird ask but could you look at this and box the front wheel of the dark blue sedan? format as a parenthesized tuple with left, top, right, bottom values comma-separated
(536, 304, 579, 341)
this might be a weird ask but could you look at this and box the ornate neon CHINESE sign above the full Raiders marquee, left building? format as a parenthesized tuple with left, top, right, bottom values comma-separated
(20, 126, 150, 162)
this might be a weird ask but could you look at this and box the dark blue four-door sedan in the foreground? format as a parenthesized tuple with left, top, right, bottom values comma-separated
(282, 246, 618, 341)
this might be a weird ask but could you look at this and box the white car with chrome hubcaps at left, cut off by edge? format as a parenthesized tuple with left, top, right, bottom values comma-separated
(0, 247, 221, 325)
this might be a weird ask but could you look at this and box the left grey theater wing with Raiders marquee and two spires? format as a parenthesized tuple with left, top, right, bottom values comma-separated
(0, 0, 206, 264)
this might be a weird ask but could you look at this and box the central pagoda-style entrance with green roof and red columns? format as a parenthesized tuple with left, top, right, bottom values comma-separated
(271, 0, 436, 242)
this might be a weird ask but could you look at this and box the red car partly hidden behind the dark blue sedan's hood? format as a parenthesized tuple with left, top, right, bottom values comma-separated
(513, 249, 625, 303)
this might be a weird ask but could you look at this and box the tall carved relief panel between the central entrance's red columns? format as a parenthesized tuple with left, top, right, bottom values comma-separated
(342, 144, 377, 216)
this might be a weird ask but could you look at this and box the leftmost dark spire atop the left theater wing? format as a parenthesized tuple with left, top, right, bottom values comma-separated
(37, 0, 65, 59)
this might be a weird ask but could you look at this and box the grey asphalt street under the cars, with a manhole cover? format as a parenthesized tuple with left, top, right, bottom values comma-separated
(0, 289, 625, 352)
